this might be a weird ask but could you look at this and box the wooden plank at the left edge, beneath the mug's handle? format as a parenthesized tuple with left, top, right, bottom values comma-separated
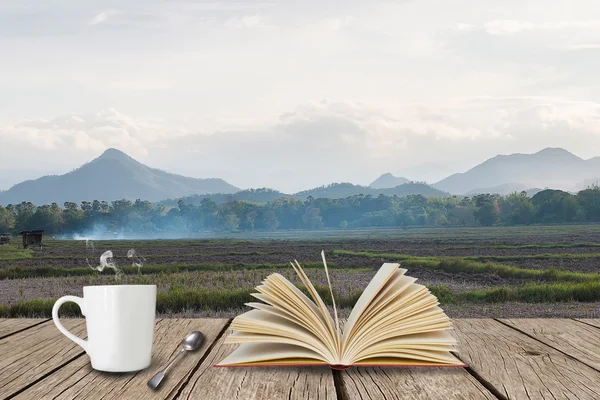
(0, 319, 85, 399)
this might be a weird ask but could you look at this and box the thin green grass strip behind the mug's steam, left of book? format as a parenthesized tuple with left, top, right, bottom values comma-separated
(0, 261, 337, 280)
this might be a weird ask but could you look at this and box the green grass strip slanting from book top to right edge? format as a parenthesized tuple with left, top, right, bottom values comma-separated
(330, 250, 600, 282)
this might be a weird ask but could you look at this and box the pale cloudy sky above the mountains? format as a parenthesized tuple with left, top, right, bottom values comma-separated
(0, 0, 600, 192)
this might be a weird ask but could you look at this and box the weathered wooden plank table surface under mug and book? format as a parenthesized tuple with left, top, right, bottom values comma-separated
(0, 319, 600, 400)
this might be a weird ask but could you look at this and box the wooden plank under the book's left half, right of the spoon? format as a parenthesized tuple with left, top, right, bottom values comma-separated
(178, 337, 337, 400)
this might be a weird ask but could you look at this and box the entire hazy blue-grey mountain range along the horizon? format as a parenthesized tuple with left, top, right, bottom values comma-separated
(0, 148, 600, 205)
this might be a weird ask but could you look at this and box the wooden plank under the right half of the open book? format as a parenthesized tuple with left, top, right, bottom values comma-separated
(340, 367, 496, 400)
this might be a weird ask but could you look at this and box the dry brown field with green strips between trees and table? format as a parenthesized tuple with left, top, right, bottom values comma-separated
(0, 225, 600, 318)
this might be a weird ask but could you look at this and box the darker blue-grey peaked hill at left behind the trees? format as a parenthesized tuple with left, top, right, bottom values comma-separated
(0, 149, 239, 205)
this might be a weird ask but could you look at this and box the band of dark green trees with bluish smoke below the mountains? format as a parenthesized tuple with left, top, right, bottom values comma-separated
(0, 186, 600, 234)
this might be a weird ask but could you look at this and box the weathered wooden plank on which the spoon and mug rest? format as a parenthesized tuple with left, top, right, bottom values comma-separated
(15, 319, 229, 400)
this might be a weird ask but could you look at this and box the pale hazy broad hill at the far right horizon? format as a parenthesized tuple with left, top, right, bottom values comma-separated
(433, 148, 600, 194)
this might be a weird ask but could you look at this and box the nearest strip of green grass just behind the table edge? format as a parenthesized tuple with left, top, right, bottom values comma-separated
(0, 282, 600, 318)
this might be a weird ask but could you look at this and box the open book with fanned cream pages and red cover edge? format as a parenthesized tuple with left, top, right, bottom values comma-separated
(216, 252, 466, 369)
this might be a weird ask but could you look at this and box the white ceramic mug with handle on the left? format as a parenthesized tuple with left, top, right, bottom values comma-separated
(52, 285, 156, 372)
